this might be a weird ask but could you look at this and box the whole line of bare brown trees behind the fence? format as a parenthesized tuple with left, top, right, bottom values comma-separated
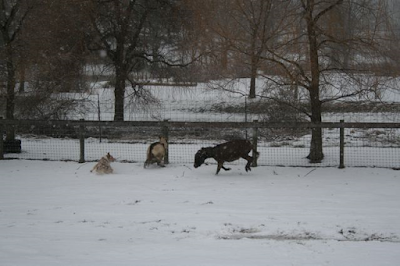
(0, 0, 400, 162)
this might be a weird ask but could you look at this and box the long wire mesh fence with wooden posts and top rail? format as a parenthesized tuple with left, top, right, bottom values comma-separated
(0, 120, 400, 168)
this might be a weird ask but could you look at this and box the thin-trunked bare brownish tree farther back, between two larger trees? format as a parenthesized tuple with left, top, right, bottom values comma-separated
(195, 0, 288, 98)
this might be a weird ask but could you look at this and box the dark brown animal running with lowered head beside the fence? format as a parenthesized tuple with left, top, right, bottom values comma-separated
(194, 140, 258, 174)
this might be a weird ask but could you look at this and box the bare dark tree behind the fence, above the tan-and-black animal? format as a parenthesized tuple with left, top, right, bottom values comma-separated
(89, 0, 186, 120)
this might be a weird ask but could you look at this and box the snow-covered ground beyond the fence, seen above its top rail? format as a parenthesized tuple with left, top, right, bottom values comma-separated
(60, 78, 400, 122)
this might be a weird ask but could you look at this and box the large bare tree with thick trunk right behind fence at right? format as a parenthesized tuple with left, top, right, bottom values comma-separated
(263, 0, 396, 162)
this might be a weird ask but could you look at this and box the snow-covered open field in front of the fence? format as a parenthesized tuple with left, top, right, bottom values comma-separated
(0, 160, 400, 266)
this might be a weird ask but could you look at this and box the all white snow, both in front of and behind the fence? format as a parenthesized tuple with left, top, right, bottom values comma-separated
(4, 75, 400, 266)
